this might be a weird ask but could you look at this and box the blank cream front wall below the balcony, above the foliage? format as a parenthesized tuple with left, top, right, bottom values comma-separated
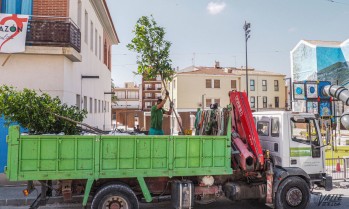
(0, 54, 65, 98)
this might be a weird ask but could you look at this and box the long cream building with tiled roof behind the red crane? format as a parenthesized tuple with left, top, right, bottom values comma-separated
(170, 63, 285, 112)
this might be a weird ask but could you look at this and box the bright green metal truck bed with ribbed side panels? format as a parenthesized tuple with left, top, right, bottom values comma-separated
(5, 126, 232, 181)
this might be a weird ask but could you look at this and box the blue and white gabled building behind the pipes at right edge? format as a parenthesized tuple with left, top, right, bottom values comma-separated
(291, 39, 349, 114)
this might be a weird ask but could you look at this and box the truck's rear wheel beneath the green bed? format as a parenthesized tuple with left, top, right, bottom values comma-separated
(91, 184, 139, 209)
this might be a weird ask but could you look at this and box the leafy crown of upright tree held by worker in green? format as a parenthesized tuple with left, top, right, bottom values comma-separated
(127, 16, 174, 82)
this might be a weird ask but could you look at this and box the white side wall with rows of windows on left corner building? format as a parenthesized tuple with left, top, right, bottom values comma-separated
(64, 0, 111, 130)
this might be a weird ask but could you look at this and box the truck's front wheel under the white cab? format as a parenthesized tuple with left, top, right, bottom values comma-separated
(275, 176, 310, 209)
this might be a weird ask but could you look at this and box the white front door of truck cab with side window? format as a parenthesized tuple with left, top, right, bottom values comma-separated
(290, 116, 324, 174)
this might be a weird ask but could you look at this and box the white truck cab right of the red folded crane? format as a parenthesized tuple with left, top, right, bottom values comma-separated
(253, 111, 330, 189)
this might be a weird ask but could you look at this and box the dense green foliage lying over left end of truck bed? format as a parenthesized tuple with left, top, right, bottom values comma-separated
(0, 85, 87, 135)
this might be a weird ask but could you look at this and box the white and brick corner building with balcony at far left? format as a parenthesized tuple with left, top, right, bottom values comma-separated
(0, 0, 119, 130)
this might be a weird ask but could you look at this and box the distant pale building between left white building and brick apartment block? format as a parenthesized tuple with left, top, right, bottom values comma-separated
(112, 82, 143, 129)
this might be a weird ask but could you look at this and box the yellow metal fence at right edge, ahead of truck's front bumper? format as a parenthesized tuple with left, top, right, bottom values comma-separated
(326, 158, 349, 181)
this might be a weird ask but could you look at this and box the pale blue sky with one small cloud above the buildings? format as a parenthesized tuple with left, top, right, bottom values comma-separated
(107, 0, 349, 86)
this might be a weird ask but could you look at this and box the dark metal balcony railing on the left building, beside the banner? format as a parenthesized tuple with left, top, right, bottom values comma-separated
(26, 16, 81, 52)
